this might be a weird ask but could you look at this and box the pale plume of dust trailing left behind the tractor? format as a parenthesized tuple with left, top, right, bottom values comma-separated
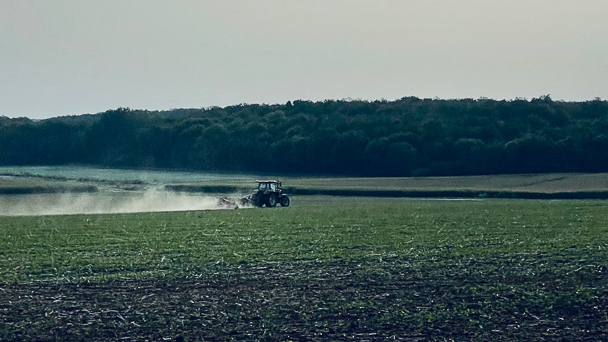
(0, 189, 238, 216)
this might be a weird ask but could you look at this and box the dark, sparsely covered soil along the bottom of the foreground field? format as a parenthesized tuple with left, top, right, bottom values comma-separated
(0, 255, 608, 341)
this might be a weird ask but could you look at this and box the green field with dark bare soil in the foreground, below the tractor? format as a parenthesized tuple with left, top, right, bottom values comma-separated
(0, 196, 608, 341)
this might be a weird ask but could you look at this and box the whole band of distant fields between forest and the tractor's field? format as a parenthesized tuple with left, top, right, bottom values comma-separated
(0, 166, 608, 199)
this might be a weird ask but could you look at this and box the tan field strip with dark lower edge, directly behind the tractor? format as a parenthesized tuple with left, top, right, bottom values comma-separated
(166, 173, 608, 199)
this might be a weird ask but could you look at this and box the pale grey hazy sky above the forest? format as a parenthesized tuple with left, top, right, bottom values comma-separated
(0, 0, 608, 118)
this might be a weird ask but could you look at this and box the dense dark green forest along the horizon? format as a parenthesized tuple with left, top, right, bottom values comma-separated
(0, 95, 608, 176)
